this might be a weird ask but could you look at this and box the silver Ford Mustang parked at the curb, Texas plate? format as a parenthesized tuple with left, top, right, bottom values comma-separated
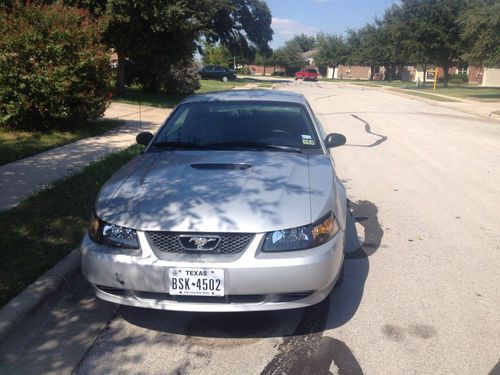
(82, 90, 347, 311)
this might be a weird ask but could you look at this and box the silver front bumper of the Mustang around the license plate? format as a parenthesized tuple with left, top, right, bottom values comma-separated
(81, 232, 344, 312)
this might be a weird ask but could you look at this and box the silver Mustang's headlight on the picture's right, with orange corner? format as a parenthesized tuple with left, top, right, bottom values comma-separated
(262, 212, 339, 252)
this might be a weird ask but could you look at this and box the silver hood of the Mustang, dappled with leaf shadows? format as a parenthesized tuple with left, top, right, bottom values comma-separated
(96, 151, 334, 233)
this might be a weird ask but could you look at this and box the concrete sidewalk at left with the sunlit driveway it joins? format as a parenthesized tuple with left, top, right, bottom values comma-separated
(0, 103, 170, 210)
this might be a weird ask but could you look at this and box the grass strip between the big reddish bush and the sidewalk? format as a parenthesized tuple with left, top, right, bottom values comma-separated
(0, 120, 123, 165)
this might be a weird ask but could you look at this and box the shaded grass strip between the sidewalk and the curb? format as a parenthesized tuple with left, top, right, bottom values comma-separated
(0, 146, 140, 306)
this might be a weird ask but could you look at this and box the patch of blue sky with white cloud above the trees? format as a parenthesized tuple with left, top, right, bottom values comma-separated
(266, 0, 399, 49)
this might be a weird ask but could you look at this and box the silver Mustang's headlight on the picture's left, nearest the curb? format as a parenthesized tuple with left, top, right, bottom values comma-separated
(89, 214, 139, 249)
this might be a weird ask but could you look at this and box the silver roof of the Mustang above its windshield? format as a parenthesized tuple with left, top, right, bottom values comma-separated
(181, 89, 306, 104)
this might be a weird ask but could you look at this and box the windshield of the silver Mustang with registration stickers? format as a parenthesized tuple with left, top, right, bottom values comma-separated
(153, 101, 321, 153)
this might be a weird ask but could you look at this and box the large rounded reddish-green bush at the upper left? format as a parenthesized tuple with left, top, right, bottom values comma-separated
(0, 4, 111, 130)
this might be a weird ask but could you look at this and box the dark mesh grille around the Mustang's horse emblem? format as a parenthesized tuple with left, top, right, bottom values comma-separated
(146, 232, 254, 254)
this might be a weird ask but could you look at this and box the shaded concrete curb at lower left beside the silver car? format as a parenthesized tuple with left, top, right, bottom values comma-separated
(0, 248, 80, 341)
